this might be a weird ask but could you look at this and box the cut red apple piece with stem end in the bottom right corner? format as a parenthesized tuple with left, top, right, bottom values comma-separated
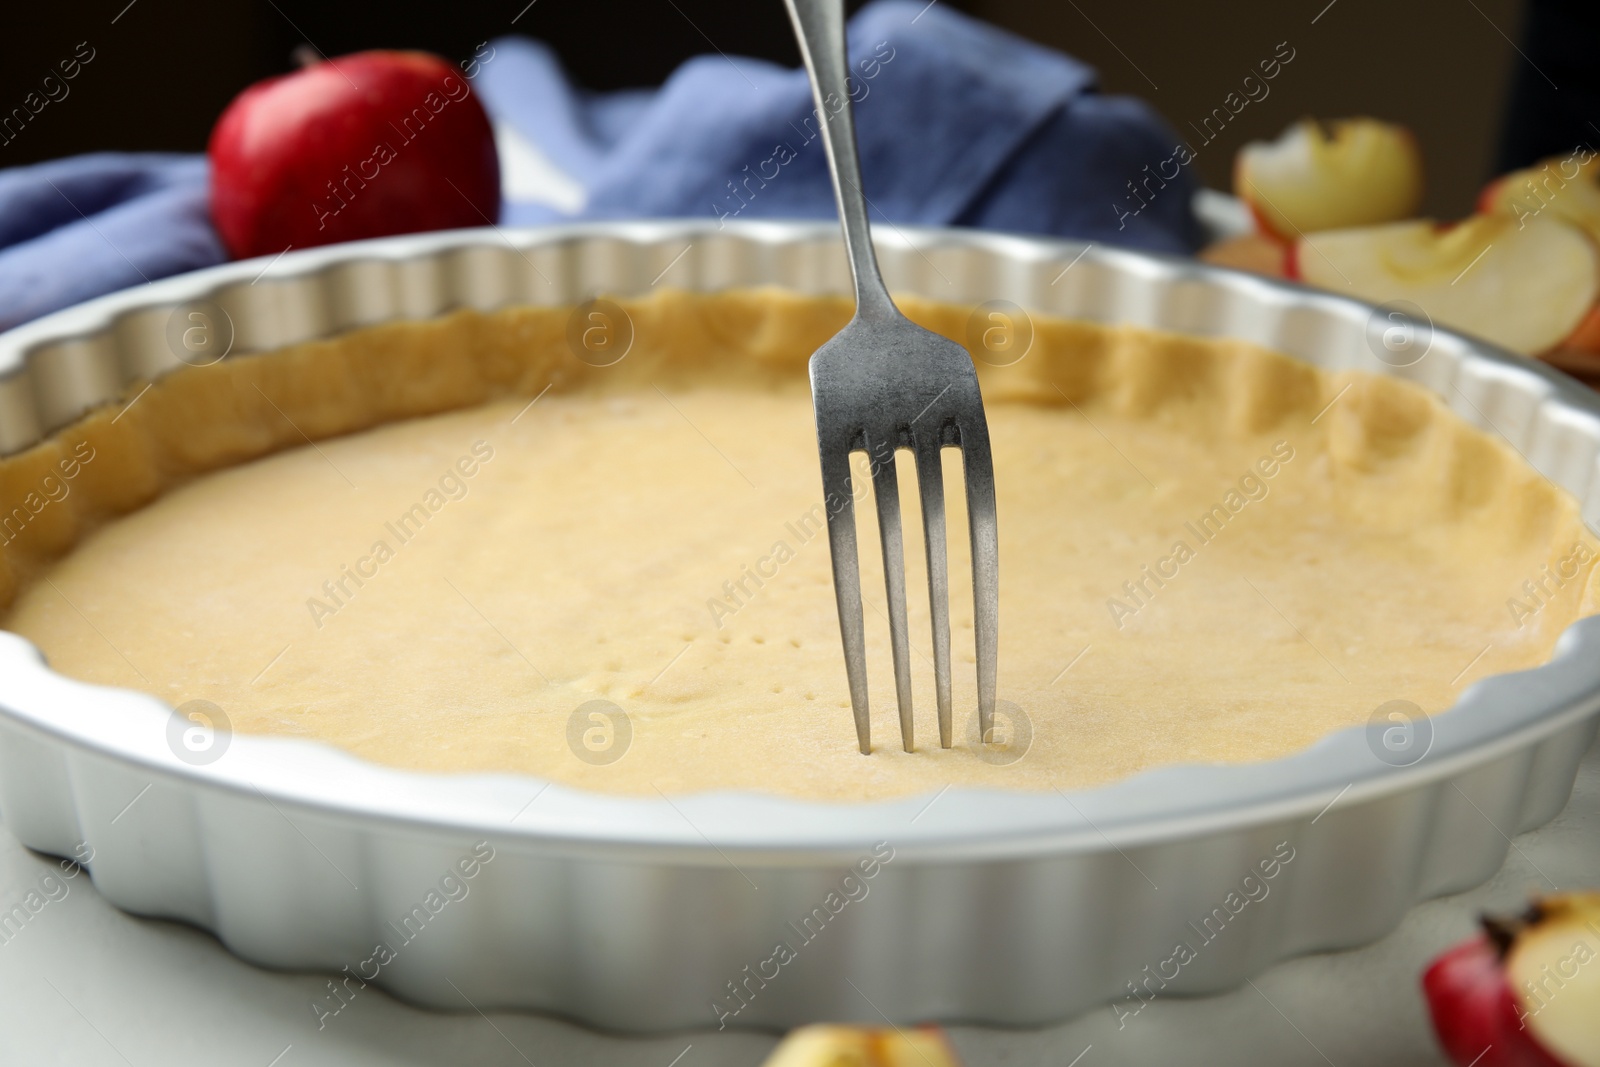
(1422, 893, 1600, 1067)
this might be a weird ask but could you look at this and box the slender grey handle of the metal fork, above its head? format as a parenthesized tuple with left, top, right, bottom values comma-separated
(784, 0, 901, 320)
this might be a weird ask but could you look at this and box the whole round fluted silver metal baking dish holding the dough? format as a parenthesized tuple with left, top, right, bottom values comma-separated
(0, 222, 1600, 1030)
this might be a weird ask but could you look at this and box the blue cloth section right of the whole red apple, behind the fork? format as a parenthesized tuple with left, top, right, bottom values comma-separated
(474, 0, 1202, 253)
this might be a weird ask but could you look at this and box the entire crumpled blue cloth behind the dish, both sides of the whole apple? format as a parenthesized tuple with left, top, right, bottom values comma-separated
(0, 0, 1202, 328)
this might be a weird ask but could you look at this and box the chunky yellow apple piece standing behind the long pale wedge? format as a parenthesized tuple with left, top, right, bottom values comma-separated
(1234, 118, 1422, 242)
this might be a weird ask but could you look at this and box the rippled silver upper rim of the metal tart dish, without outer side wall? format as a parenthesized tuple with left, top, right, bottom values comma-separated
(0, 222, 1600, 854)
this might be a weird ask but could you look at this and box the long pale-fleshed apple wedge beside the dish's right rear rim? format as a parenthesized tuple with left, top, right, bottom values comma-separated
(1293, 214, 1600, 355)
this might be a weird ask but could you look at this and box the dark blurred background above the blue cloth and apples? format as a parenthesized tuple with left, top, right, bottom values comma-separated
(0, 0, 1600, 216)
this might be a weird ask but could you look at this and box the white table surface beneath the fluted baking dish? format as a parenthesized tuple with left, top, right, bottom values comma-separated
(0, 735, 1600, 1067)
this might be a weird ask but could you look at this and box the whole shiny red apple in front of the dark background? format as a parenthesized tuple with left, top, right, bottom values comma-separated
(208, 51, 499, 258)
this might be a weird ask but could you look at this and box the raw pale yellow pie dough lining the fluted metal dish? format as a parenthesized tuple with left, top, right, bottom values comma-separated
(0, 291, 1597, 800)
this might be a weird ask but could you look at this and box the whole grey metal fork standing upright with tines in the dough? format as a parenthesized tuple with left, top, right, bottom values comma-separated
(786, 0, 1000, 753)
